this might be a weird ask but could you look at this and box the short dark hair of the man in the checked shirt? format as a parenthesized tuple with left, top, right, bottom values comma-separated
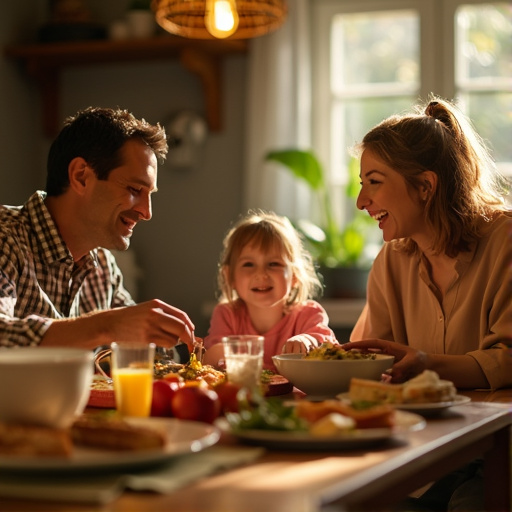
(46, 107, 168, 196)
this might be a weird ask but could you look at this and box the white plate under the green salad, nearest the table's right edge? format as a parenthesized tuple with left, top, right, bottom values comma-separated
(217, 411, 426, 450)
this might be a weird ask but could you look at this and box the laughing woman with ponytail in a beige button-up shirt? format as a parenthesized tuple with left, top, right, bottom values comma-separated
(345, 99, 512, 388)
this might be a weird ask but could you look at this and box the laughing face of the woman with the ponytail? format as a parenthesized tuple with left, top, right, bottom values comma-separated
(357, 149, 429, 245)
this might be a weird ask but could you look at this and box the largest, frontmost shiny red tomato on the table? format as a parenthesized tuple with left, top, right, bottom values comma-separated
(171, 386, 220, 423)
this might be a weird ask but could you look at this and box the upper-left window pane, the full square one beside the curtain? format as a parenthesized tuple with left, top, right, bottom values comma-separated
(331, 11, 419, 94)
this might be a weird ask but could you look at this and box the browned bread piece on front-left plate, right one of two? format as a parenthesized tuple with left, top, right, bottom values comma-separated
(71, 415, 166, 451)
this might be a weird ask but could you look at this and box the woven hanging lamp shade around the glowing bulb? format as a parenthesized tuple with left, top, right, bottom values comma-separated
(151, 0, 288, 39)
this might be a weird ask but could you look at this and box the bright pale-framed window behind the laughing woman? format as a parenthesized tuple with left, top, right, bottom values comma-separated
(311, 0, 512, 228)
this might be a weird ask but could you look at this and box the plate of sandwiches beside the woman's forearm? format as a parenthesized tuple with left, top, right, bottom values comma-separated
(338, 370, 471, 415)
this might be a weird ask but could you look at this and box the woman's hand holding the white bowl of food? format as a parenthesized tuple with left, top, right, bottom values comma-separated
(343, 339, 427, 382)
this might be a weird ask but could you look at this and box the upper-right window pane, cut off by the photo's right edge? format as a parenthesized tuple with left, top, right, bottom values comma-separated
(456, 2, 512, 83)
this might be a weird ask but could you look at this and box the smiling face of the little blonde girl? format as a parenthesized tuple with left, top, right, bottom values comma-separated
(232, 241, 295, 308)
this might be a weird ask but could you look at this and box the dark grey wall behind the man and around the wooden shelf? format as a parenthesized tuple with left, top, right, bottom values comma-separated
(0, 0, 247, 336)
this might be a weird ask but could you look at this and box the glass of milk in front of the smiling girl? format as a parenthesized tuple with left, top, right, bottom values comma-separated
(222, 334, 265, 389)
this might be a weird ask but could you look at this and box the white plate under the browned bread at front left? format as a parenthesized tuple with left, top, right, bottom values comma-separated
(0, 418, 220, 472)
